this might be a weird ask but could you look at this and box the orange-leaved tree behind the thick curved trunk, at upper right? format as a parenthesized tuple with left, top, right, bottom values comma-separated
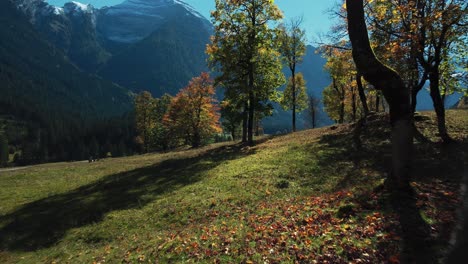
(367, 0, 467, 142)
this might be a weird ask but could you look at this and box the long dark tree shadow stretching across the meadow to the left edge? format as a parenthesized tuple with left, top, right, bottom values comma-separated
(0, 144, 253, 251)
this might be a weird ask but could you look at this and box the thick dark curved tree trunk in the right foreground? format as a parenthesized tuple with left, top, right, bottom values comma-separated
(346, 0, 413, 190)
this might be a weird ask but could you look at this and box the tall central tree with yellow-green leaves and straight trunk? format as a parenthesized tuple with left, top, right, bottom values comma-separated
(206, 0, 284, 144)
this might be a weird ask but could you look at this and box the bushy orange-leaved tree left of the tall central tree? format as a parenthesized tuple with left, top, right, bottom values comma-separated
(164, 72, 222, 147)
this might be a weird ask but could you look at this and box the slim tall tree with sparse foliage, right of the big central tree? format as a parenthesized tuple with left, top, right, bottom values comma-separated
(278, 18, 307, 132)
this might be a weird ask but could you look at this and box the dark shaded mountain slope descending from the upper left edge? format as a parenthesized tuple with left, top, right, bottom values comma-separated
(0, 1, 131, 119)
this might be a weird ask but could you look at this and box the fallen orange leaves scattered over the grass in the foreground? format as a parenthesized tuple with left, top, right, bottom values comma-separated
(155, 192, 400, 263)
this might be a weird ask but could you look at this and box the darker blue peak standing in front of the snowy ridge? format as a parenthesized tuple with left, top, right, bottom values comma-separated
(98, 5, 210, 94)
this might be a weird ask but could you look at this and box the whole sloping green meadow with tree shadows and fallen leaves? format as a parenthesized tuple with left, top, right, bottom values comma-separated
(0, 110, 468, 263)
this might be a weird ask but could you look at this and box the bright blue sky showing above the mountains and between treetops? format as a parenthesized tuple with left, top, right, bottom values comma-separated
(46, 0, 336, 41)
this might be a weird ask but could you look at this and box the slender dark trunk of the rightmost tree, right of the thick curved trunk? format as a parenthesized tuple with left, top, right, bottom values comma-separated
(429, 70, 452, 143)
